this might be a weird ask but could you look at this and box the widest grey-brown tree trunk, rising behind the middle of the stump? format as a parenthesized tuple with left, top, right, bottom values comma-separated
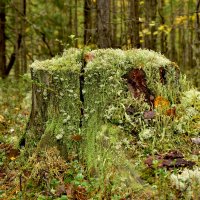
(97, 0, 111, 48)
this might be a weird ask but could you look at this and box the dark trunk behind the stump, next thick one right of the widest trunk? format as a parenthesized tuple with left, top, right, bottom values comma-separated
(129, 0, 140, 48)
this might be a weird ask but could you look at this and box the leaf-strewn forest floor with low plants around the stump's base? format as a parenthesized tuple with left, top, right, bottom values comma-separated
(0, 79, 200, 200)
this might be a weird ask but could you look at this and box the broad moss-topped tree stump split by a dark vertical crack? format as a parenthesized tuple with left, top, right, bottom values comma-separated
(25, 49, 181, 160)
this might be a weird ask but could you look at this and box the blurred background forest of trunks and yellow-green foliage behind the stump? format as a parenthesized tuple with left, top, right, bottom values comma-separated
(0, 0, 200, 84)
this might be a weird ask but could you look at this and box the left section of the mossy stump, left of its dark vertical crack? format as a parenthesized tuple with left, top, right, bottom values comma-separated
(26, 49, 82, 156)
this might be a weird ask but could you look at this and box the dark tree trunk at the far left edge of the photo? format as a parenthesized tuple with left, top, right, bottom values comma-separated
(0, 1, 6, 78)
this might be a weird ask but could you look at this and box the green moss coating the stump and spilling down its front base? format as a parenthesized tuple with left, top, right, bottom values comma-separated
(26, 49, 196, 196)
